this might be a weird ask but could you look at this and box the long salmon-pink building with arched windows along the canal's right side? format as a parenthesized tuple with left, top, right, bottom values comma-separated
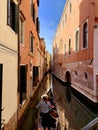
(53, 0, 98, 102)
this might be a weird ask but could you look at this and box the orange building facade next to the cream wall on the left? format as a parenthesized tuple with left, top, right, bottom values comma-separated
(18, 0, 40, 120)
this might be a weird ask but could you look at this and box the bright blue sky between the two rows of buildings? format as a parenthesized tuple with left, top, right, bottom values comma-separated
(38, 0, 66, 53)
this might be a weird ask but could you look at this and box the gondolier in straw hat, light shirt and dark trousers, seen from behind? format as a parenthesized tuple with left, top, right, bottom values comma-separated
(36, 95, 51, 130)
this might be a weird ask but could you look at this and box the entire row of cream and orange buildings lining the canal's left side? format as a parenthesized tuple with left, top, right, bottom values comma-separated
(0, 0, 47, 130)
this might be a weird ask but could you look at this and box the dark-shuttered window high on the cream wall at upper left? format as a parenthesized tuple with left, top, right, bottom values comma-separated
(7, 0, 19, 33)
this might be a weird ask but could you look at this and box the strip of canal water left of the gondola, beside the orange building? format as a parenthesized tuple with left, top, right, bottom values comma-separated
(17, 74, 51, 130)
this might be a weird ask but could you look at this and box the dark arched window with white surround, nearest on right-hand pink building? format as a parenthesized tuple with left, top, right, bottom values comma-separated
(83, 22, 88, 48)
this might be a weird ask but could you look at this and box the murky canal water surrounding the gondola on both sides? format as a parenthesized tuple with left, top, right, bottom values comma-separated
(21, 74, 98, 130)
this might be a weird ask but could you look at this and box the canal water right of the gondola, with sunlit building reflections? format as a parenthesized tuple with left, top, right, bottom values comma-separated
(52, 77, 98, 130)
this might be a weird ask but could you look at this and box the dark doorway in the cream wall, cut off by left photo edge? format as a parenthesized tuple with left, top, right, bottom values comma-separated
(0, 64, 3, 130)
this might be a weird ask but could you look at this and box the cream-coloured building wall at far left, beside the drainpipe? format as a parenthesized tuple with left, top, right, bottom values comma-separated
(0, 0, 18, 130)
